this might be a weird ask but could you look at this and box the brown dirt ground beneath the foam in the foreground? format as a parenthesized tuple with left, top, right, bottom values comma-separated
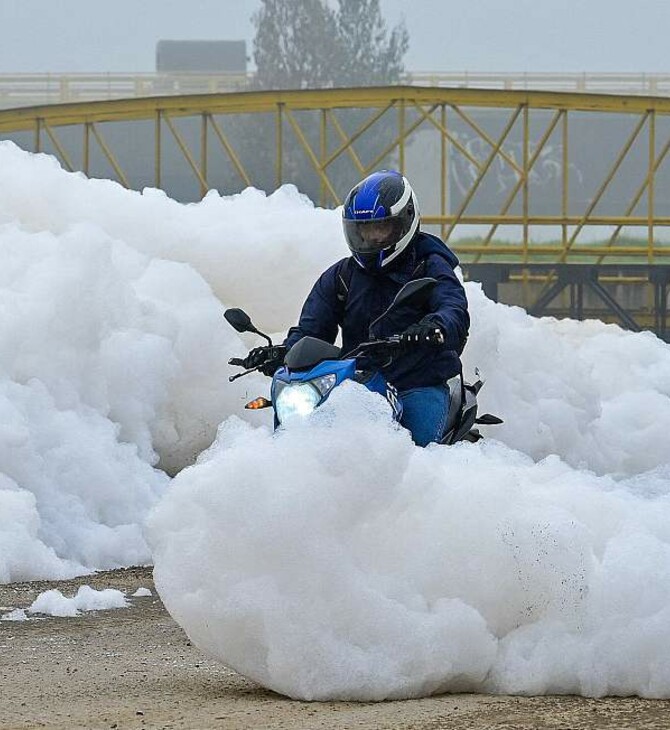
(0, 568, 670, 730)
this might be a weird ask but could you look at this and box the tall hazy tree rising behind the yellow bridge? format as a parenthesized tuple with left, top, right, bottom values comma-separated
(215, 0, 409, 201)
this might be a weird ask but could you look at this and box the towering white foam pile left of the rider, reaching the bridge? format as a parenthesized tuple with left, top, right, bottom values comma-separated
(0, 143, 342, 582)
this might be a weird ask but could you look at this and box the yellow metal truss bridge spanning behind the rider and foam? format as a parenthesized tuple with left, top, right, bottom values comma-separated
(0, 86, 670, 336)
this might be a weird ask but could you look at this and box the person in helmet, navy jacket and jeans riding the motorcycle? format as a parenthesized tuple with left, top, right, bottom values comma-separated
(246, 170, 470, 446)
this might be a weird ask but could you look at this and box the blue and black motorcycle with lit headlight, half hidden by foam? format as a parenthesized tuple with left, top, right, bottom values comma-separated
(224, 277, 502, 444)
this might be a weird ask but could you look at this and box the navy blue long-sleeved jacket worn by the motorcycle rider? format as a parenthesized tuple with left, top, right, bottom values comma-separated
(284, 232, 470, 391)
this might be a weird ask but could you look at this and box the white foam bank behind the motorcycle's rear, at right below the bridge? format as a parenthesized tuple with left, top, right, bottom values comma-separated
(464, 284, 670, 477)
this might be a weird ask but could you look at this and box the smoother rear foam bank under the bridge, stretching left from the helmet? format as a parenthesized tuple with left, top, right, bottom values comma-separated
(0, 143, 347, 332)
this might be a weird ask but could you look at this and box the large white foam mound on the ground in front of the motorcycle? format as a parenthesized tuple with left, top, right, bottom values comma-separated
(151, 385, 670, 700)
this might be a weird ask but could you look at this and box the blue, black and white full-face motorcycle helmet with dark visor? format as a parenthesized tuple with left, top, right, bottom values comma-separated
(342, 170, 419, 271)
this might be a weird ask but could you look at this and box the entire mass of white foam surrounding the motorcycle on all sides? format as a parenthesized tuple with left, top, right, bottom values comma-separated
(0, 139, 670, 700)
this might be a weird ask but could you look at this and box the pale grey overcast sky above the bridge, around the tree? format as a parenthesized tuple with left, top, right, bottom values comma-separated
(0, 0, 670, 73)
